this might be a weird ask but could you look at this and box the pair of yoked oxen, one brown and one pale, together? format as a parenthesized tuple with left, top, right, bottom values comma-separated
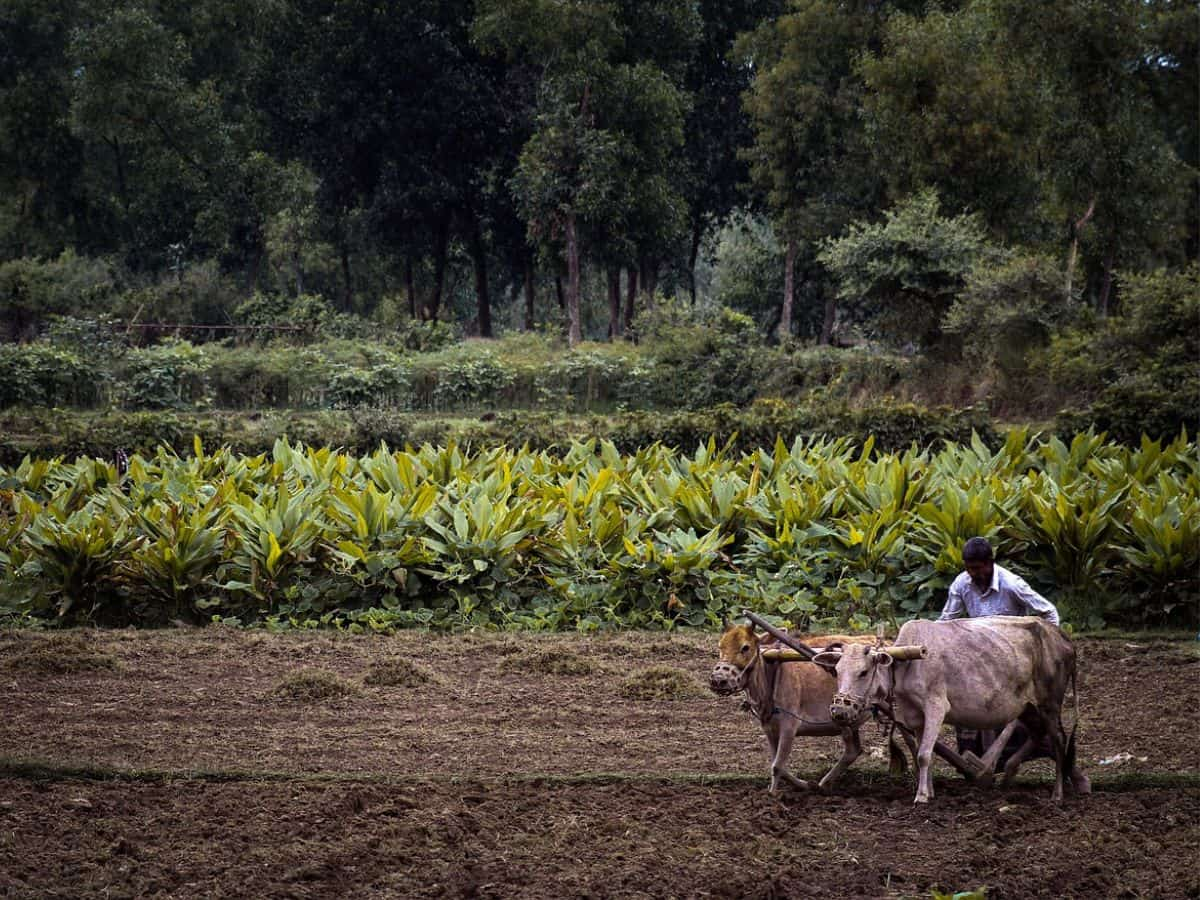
(709, 616, 1090, 803)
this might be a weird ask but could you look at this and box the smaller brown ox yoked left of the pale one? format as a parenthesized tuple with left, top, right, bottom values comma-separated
(709, 625, 906, 792)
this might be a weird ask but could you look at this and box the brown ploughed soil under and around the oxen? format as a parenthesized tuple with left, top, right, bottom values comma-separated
(0, 628, 1200, 898)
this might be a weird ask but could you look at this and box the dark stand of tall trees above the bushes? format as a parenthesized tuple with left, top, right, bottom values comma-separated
(0, 0, 1200, 343)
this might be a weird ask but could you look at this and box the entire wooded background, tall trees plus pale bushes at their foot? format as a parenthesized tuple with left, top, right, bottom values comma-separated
(0, 0, 1200, 440)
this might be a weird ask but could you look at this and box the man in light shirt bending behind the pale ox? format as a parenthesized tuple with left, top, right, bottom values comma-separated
(937, 538, 1058, 772)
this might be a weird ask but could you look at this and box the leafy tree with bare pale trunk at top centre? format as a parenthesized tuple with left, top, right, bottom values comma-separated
(474, 0, 691, 346)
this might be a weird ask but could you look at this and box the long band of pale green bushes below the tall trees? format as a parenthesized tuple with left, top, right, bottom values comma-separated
(0, 328, 912, 413)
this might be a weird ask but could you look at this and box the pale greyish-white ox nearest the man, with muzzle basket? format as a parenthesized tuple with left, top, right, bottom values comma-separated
(815, 616, 1088, 803)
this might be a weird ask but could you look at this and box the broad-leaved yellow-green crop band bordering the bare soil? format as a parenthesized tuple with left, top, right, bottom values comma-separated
(0, 430, 1200, 630)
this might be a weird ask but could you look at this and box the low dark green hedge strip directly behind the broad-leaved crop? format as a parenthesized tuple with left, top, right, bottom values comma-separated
(0, 401, 998, 466)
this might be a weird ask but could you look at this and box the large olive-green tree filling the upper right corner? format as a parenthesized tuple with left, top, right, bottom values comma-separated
(860, 0, 1196, 314)
